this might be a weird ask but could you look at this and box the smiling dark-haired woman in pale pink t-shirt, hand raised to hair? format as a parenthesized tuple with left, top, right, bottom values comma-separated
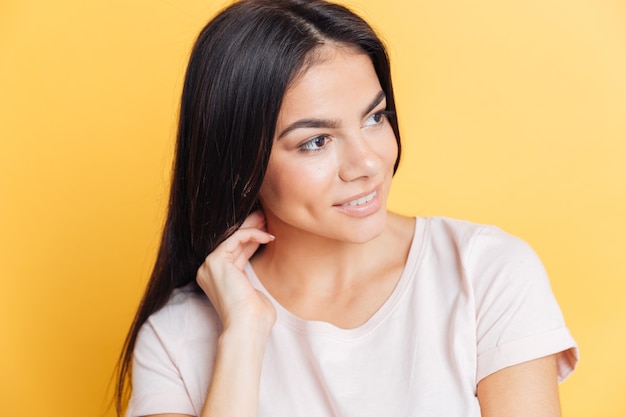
(118, 0, 576, 417)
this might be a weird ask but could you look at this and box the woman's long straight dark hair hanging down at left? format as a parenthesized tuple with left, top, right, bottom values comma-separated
(115, 0, 400, 415)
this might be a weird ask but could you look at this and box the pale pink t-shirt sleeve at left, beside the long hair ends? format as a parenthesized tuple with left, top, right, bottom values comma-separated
(126, 319, 195, 417)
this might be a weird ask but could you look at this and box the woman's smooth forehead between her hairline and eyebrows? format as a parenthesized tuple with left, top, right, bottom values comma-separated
(278, 44, 381, 123)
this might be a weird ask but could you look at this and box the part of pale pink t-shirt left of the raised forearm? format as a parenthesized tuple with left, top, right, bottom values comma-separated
(128, 286, 220, 415)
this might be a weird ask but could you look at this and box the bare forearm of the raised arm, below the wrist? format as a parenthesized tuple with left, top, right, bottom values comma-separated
(201, 324, 269, 417)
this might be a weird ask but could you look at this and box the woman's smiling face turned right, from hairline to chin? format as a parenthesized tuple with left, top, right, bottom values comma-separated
(259, 46, 398, 243)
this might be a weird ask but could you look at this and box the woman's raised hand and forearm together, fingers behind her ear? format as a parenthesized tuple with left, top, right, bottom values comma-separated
(196, 211, 276, 417)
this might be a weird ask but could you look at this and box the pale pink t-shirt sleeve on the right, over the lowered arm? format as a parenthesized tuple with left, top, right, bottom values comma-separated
(467, 228, 578, 382)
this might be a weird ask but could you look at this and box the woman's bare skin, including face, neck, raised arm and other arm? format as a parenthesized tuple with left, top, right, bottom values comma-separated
(140, 45, 560, 417)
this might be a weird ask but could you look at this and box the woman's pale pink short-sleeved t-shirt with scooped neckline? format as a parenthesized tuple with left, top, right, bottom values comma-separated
(127, 218, 578, 417)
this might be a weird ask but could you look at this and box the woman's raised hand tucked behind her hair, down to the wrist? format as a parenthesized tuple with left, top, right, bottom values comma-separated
(196, 211, 276, 335)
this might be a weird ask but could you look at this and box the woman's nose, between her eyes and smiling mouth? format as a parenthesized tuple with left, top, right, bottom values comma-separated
(338, 134, 382, 182)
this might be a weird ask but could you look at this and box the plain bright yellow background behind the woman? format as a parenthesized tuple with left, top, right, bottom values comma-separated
(0, 0, 626, 417)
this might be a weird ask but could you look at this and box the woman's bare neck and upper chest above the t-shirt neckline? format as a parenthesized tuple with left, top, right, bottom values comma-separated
(251, 213, 415, 329)
